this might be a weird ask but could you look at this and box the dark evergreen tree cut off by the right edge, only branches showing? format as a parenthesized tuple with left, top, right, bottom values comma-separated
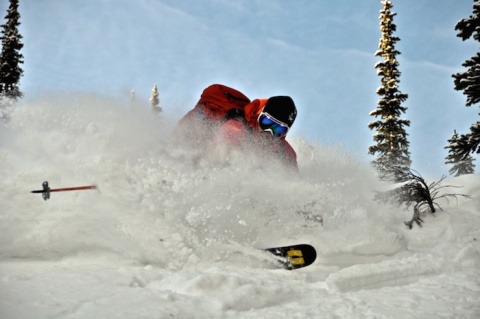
(451, 0, 480, 159)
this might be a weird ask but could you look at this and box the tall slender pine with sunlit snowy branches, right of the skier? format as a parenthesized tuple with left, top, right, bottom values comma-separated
(368, 0, 411, 181)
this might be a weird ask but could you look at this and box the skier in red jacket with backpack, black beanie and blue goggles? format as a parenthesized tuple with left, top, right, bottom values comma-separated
(175, 84, 298, 170)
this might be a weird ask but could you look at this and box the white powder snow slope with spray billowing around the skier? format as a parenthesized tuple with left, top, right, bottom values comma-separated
(0, 95, 480, 318)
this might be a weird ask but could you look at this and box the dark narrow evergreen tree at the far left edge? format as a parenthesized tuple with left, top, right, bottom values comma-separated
(0, 0, 23, 99)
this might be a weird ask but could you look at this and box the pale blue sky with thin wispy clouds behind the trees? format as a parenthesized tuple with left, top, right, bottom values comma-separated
(4, 0, 480, 177)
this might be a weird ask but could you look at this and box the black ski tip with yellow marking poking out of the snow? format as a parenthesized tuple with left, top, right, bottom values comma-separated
(262, 244, 317, 270)
